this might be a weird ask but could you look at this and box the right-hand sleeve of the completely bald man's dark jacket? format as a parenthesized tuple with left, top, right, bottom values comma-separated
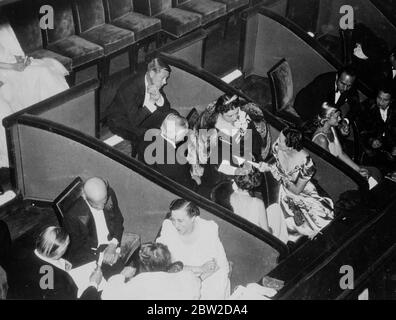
(105, 188, 124, 243)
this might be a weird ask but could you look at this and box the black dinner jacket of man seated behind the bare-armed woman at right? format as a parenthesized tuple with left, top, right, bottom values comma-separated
(294, 72, 360, 121)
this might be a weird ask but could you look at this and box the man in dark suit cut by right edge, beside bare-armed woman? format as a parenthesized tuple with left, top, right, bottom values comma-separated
(361, 84, 396, 174)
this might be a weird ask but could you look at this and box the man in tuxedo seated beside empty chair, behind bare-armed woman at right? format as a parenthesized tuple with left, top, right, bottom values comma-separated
(294, 66, 360, 121)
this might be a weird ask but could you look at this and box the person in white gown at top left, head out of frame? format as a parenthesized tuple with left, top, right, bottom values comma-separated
(0, 21, 69, 112)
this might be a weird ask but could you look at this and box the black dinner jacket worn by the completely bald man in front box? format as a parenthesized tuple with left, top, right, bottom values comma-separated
(63, 187, 124, 266)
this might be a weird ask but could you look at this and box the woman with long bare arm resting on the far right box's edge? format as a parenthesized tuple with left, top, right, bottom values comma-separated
(312, 102, 381, 181)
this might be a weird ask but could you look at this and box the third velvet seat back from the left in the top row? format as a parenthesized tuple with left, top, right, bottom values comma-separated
(75, 0, 106, 32)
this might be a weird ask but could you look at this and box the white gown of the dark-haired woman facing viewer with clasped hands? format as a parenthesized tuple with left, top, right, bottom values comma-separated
(157, 217, 230, 300)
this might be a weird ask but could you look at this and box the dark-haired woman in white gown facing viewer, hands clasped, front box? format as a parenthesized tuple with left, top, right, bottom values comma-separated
(157, 199, 230, 300)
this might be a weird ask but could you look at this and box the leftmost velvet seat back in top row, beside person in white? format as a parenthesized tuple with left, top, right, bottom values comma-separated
(5, 1, 43, 54)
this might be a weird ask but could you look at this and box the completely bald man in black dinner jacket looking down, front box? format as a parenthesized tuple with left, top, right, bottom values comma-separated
(64, 177, 124, 267)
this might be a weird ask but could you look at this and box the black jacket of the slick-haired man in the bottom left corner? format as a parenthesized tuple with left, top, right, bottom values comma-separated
(8, 252, 100, 300)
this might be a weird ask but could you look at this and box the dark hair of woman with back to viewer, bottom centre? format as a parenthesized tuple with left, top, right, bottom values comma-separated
(139, 242, 172, 272)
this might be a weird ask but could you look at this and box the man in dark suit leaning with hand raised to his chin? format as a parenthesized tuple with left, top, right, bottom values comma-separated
(104, 58, 173, 156)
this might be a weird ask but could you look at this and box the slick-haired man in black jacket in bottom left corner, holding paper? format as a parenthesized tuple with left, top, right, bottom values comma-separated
(9, 226, 102, 300)
